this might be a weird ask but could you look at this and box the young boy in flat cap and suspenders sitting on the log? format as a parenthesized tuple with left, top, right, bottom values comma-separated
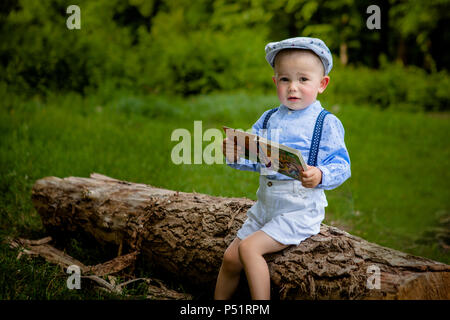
(214, 37, 350, 300)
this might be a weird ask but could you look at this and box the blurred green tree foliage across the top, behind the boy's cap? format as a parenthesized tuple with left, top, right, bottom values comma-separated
(0, 0, 450, 109)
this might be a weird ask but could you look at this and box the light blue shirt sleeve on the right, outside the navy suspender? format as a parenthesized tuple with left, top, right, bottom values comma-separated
(317, 114, 351, 190)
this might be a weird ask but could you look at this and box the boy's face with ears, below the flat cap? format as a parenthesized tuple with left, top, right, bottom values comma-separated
(273, 50, 330, 110)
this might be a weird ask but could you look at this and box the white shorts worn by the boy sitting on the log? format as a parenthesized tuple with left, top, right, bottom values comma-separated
(237, 175, 328, 245)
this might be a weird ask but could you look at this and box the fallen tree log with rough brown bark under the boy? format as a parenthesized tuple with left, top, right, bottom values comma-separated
(32, 174, 450, 299)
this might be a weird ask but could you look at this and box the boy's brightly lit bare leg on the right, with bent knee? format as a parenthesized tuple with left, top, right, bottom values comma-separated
(239, 231, 288, 300)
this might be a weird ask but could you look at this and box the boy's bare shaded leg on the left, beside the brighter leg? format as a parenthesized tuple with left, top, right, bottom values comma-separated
(214, 238, 243, 300)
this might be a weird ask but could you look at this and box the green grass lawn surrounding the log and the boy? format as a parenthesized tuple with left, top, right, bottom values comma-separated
(0, 92, 450, 299)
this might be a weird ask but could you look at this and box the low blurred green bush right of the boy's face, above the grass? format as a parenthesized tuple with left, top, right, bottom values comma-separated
(327, 64, 450, 111)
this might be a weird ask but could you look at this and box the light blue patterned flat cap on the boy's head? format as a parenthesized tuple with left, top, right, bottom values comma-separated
(265, 37, 333, 74)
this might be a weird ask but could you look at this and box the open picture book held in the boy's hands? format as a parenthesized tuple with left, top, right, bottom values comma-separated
(223, 126, 307, 180)
